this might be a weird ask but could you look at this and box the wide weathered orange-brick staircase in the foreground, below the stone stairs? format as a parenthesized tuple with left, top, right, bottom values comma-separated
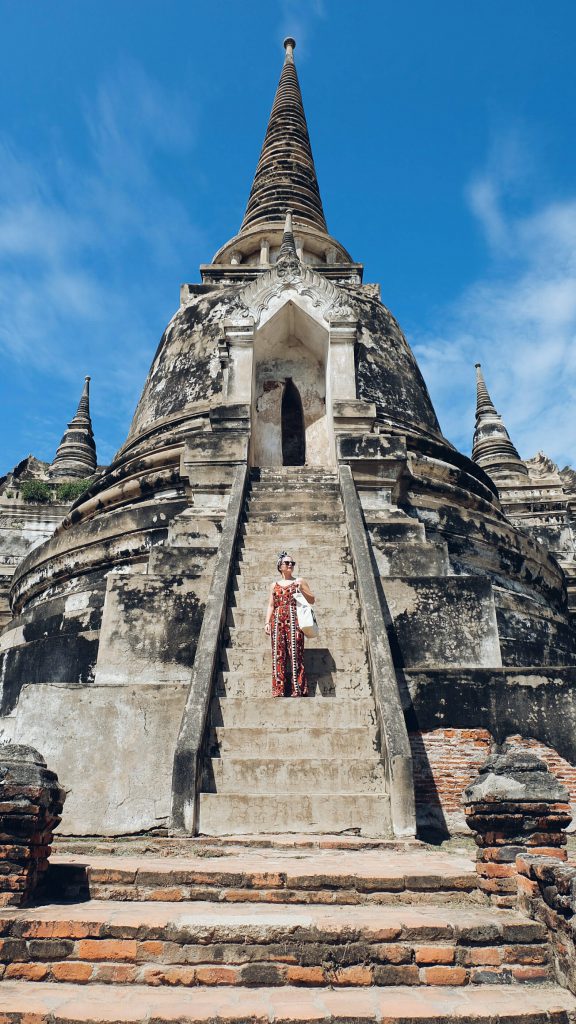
(0, 837, 576, 1024)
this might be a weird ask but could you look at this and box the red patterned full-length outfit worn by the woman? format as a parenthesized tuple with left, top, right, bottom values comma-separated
(271, 582, 308, 697)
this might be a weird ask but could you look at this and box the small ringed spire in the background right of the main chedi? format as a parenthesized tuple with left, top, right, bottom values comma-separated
(472, 362, 528, 483)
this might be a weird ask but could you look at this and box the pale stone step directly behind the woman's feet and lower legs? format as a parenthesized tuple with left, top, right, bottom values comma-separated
(214, 667, 372, 700)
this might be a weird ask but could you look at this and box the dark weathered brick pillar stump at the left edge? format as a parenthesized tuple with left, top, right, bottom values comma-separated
(0, 743, 66, 906)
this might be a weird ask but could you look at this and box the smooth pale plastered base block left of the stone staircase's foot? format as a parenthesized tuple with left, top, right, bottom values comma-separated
(9, 684, 187, 836)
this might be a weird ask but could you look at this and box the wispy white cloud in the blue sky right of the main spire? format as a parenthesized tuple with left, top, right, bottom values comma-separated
(414, 136, 576, 464)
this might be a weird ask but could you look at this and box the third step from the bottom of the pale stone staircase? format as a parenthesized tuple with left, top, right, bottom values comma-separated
(209, 724, 379, 757)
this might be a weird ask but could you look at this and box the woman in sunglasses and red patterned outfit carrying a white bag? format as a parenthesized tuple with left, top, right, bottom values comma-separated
(264, 551, 316, 697)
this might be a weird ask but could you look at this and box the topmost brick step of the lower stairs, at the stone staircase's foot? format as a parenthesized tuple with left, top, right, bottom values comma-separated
(50, 836, 475, 904)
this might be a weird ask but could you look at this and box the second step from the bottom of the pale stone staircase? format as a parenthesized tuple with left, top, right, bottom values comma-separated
(202, 756, 386, 795)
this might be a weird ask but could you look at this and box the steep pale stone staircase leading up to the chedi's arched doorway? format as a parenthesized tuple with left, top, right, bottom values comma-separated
(200, 467, 390, 836)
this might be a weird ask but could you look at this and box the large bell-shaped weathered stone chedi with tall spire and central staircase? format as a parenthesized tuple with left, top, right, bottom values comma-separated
(0, 40, 576, 836)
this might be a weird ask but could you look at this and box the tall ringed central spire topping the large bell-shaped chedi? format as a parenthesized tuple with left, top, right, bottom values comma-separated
(240, 37, 328, 234)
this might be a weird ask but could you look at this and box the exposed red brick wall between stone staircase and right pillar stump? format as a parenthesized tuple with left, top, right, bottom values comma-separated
(409, 729, 492, 833)
